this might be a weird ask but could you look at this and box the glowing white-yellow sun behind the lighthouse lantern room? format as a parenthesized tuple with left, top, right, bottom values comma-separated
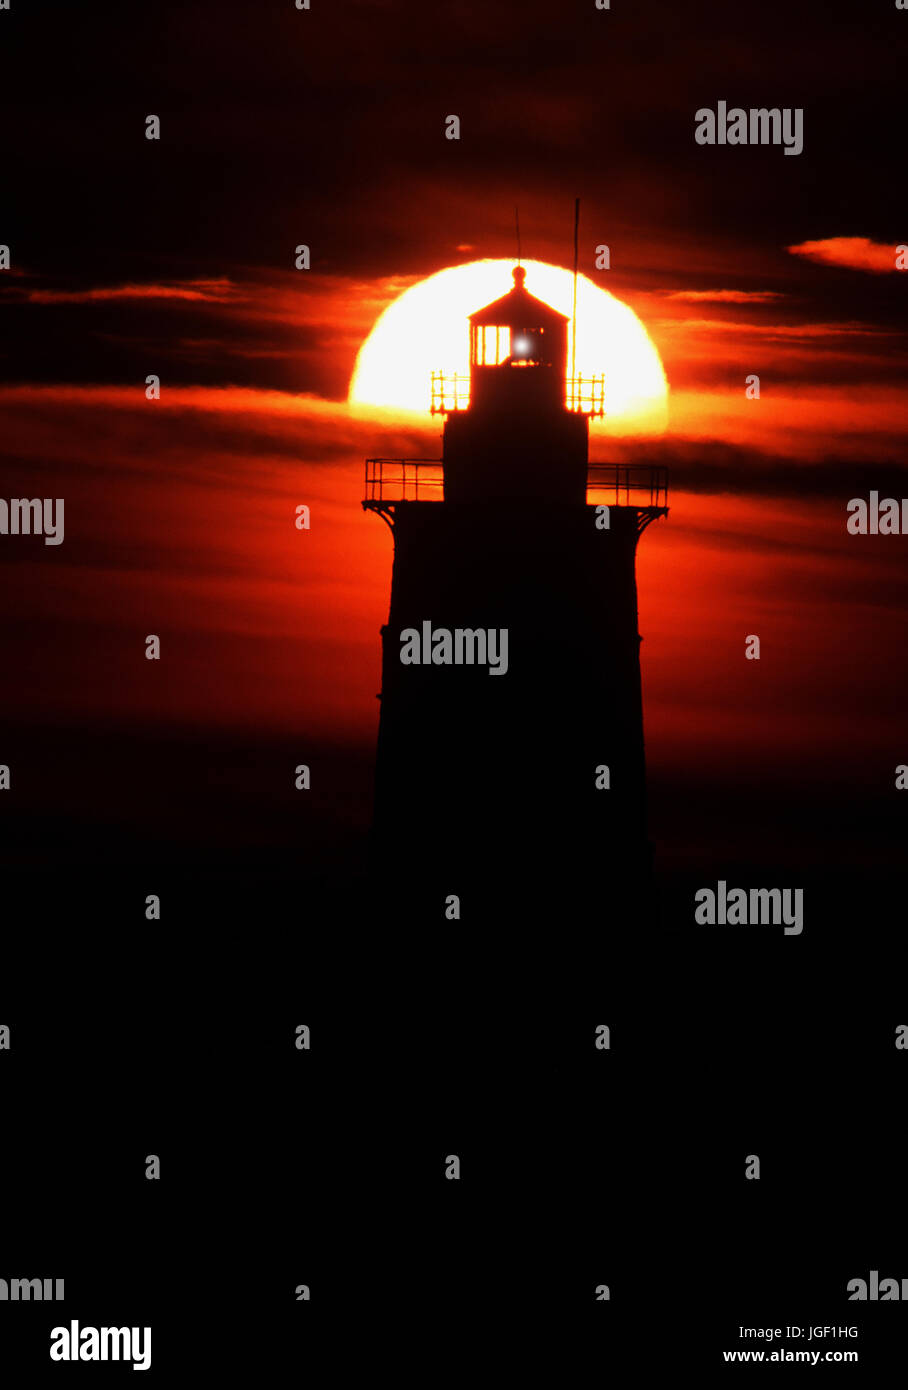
(348, 260, 669, 434)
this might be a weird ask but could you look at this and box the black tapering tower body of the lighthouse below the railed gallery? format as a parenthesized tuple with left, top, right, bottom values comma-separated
(375, 505, 648, 880)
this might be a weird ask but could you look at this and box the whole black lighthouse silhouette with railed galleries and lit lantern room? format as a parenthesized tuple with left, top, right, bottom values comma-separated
(363, 265, 667, 891)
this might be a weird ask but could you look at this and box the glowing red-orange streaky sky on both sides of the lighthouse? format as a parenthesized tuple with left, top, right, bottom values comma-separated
(0, 257, 908, 861)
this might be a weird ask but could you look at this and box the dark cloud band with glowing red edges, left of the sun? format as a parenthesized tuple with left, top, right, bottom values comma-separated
(0, 264, 403, 399)
